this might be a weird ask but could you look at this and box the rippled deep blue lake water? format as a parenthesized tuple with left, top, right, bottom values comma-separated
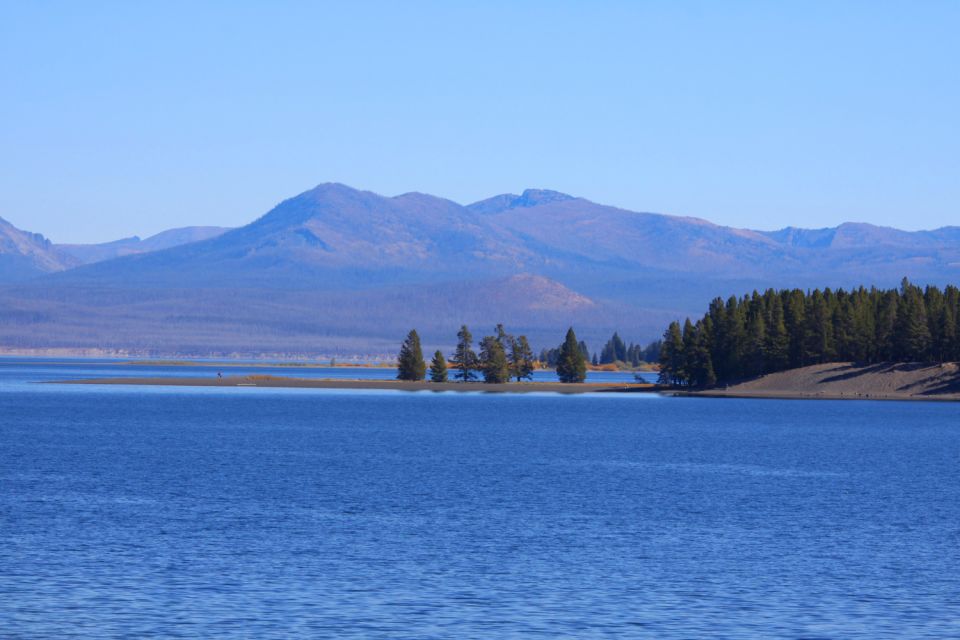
(0, 360, 960, 638)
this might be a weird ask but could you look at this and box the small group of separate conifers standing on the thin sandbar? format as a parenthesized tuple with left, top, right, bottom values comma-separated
(397, 324, 587, 384)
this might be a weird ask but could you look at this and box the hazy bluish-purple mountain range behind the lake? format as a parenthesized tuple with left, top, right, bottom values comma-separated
(0, 184, 960, 355)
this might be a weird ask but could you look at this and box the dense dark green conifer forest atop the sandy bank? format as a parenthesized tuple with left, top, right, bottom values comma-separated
(660, 278, 960, 387)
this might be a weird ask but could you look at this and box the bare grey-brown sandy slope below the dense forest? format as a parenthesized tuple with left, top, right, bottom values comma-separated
(695, 362, 960, 400)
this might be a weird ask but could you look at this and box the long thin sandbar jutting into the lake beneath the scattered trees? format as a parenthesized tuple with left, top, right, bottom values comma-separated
(48, 375, 658, 394)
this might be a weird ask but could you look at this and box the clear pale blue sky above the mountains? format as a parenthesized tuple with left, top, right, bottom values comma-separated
(0, 0, 960, 242)
